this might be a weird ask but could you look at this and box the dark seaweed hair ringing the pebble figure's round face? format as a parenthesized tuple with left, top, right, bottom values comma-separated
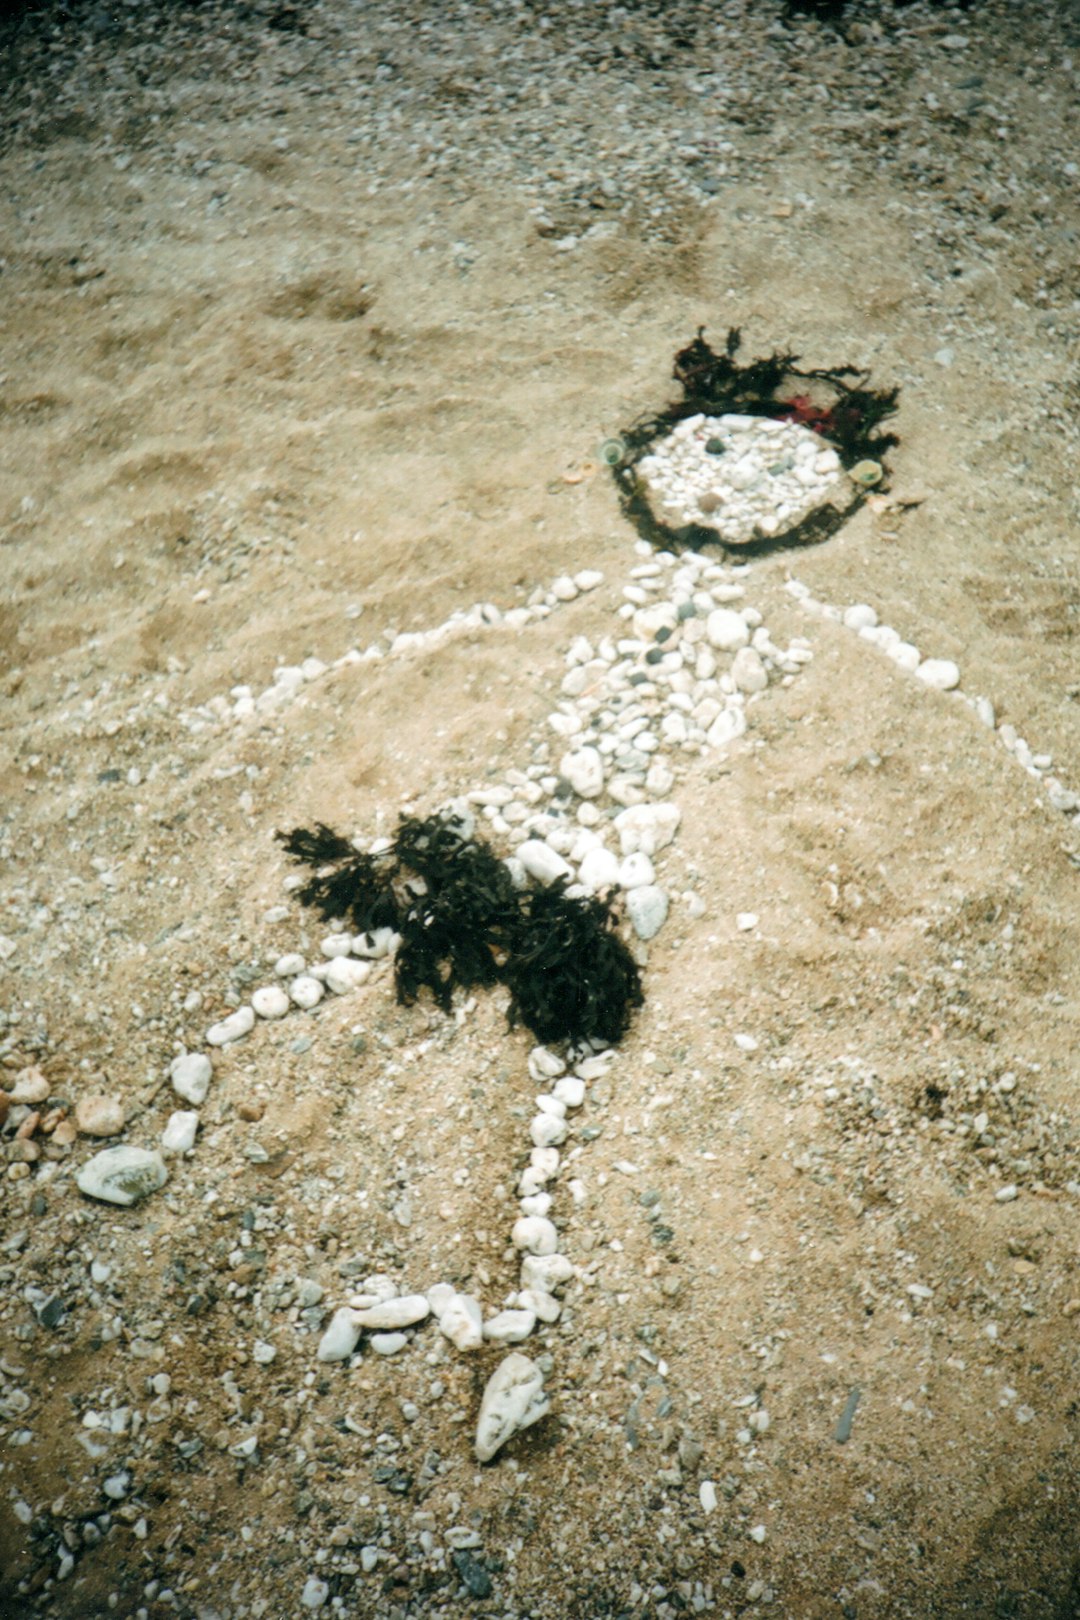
(612, 327, 900, 556)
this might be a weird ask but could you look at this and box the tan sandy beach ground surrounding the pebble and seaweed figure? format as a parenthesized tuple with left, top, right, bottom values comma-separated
(0, 0, 1080, 1620)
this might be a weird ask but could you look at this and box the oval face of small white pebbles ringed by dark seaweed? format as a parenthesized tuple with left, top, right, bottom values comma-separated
(636, 413, 852, 546)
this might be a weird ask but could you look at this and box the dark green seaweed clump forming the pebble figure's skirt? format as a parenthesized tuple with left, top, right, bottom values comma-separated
(277, 816, 643, 1047)
